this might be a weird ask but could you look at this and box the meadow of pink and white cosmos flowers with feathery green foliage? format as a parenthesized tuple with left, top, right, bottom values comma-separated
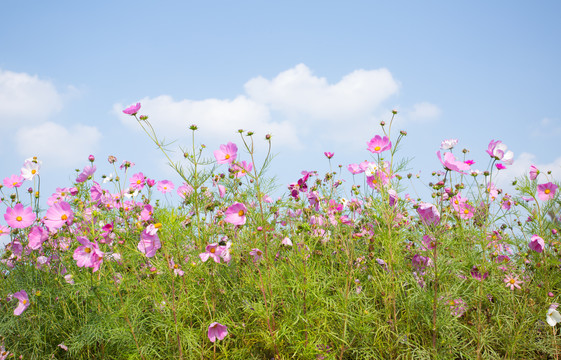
(0, 104, 561, 360)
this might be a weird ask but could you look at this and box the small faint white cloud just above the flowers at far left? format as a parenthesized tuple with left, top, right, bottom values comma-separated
(15, 122, 101, 168)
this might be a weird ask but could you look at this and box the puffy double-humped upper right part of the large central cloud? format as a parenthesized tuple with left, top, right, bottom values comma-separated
(245, 64, 399, 121)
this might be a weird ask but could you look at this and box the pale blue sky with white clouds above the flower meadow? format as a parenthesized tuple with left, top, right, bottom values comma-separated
(0, 1, 561, 211)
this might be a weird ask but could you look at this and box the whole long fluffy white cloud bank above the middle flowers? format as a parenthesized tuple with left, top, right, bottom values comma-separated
(114, 64, 399, 149)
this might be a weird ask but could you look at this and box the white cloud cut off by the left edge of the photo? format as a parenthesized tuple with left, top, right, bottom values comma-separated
(0, 70, 62, 129)
